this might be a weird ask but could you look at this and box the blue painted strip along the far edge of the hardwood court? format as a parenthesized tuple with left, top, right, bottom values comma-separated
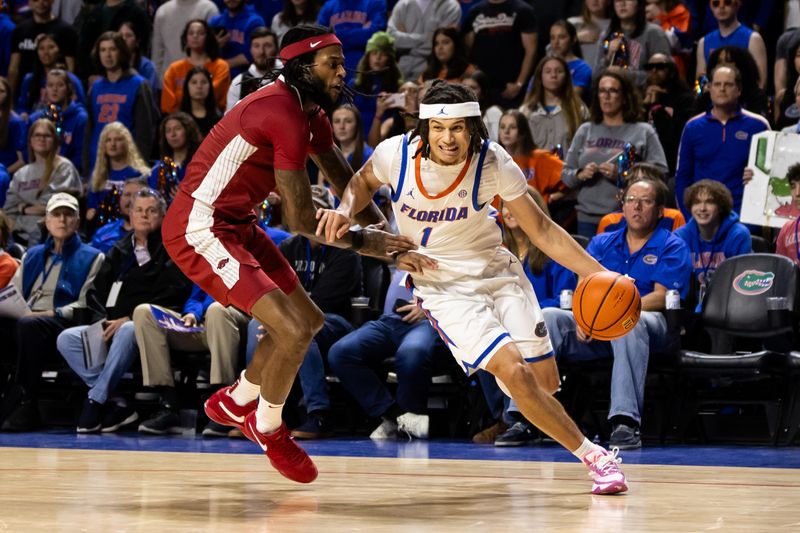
(0, 429, 800, 468)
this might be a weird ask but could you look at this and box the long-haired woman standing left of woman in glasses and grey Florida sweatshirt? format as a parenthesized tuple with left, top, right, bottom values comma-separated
(520, 56, 589, 159)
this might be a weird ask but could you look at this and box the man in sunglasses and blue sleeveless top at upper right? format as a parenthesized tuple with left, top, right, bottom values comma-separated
(695, 0, 767, 89)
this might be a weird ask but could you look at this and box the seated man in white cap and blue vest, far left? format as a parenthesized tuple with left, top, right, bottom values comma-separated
(0, 193, 103, 431)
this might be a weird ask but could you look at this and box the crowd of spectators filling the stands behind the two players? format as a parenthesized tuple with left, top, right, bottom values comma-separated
(0, 0, 800, 447)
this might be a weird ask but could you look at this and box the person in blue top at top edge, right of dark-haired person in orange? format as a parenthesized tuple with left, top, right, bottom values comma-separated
(208, 0, 266, 78)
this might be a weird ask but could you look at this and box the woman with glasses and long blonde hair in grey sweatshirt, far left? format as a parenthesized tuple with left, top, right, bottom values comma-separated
(4, 118, 82, 246)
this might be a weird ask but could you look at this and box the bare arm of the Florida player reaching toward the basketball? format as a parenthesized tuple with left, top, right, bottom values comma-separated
(504, 194, 605, 277)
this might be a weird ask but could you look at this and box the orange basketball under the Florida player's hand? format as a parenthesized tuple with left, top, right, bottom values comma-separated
(572, 271, 642, 341)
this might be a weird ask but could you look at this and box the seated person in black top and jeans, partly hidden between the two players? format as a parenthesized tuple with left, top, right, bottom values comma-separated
(247, 185, 361, 439)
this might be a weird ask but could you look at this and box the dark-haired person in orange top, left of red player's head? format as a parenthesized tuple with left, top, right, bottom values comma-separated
(161, 19, 231, 113)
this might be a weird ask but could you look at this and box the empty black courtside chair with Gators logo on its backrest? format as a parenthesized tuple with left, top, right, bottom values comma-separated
(678, 254, 798, 444)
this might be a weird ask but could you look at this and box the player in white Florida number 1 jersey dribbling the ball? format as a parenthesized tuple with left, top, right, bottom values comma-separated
(317, 81, 627, 494)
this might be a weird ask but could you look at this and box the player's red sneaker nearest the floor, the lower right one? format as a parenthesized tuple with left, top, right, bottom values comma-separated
(242, 411, 319, 483)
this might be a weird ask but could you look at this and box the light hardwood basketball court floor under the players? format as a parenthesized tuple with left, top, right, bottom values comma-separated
(0, 436, 800, 533)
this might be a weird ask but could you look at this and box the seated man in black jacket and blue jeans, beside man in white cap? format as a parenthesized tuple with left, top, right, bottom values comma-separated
(57, 189, 191, 433)
